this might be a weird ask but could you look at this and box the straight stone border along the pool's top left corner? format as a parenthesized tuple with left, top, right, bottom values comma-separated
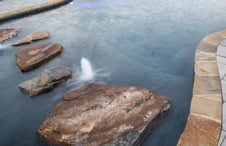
(0, 0, 72, 23)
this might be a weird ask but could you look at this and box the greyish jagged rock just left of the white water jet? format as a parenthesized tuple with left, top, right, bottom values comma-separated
(19, 66, 72, 96)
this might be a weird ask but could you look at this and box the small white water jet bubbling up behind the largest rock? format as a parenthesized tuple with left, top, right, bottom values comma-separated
(80, 57, 95, 81)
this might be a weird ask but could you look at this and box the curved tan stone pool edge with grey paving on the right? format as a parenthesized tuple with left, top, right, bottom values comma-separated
(177, 30, 226, 146)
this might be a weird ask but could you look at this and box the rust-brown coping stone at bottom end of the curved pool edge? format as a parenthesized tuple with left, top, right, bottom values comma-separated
(177, 114, 221, 146)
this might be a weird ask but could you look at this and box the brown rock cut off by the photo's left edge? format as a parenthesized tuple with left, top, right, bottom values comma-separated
(0, 28, 20, 43)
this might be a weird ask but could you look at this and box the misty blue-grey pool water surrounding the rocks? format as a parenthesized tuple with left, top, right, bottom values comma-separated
(0, 0, 226, 146)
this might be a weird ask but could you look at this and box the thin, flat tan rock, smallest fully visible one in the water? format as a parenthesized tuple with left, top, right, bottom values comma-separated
(13, 32, 50, 46)
